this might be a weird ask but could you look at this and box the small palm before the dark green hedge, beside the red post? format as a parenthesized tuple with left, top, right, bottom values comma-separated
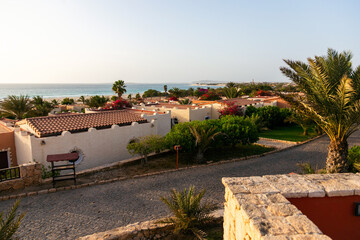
(189, 125, 220, 162)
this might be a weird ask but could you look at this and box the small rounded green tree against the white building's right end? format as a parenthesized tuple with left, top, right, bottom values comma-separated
(127, 135, 164, 165)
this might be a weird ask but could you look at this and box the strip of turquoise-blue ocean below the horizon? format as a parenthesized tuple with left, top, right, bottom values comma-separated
(0, 83, 222, 99)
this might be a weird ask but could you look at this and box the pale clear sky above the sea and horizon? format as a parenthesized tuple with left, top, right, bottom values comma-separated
(0, 0, 360, 83)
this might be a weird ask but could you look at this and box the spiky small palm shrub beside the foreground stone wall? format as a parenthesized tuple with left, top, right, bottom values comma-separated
(161, 186, 217, 239)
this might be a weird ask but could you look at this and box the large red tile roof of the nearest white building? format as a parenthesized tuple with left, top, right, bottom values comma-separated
(26, 110, 147, 137)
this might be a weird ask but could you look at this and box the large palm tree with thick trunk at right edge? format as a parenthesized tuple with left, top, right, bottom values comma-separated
(280, 49, 360, 173)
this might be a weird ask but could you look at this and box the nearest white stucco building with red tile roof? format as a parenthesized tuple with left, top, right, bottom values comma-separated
(15, 109, 171, 170)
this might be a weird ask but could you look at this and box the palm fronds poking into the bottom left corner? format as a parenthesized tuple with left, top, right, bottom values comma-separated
(0, 200, 25, 240)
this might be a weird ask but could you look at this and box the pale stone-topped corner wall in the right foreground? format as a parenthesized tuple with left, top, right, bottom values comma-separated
(222, 173, 360, 240)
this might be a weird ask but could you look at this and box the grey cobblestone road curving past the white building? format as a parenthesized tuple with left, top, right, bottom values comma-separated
(0, 133, 360, 239)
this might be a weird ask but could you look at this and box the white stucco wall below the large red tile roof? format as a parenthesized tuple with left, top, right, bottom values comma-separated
(16, 113, 171, 170)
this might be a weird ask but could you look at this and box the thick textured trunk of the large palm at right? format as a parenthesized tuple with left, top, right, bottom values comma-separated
(326, 140, 348, 173)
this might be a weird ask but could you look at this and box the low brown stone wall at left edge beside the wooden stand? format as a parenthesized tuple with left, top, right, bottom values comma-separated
(0, 163, 41, 191)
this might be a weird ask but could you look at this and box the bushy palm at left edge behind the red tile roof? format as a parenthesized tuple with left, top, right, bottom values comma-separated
(0, 95, 32, 120)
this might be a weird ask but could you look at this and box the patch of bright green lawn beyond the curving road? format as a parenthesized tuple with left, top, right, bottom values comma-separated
(259, 125, 317, 142)
